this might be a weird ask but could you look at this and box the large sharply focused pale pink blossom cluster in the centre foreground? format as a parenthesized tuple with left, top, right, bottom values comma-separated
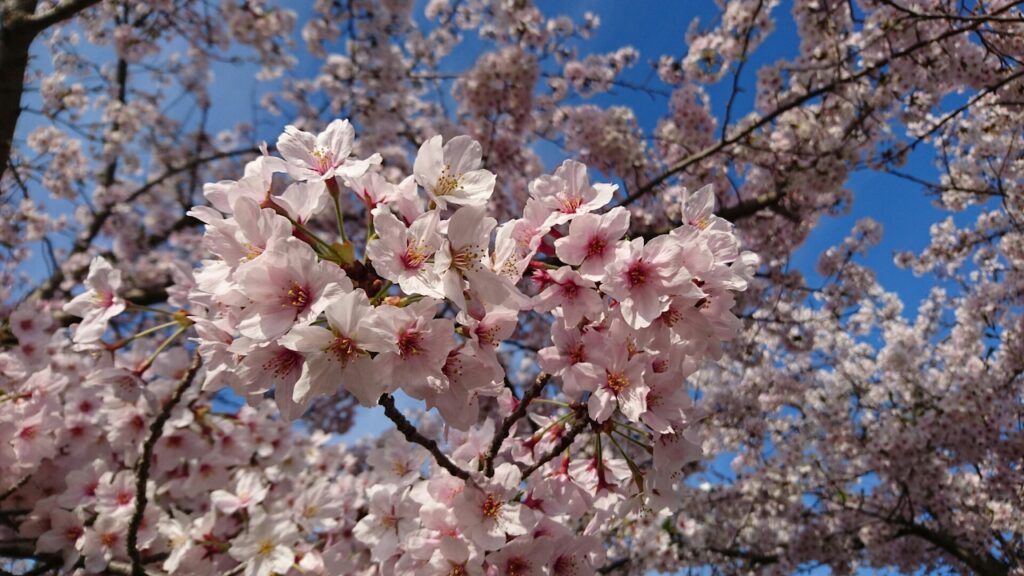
(178, 121, 756, 434)
